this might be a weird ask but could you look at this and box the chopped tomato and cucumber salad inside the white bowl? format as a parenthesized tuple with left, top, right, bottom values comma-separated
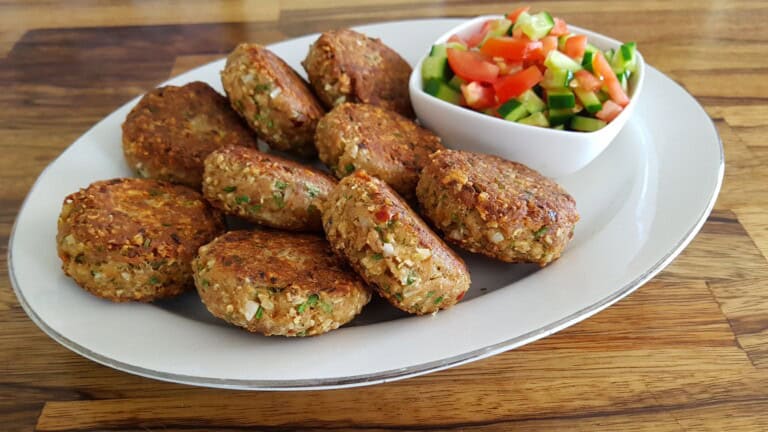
(421, 6, 637, 132)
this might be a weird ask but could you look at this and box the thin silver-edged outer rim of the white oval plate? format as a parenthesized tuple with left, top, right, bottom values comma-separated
(7, 18, 725, 391)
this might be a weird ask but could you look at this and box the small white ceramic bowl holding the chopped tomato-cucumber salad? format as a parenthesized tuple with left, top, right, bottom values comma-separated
(408, 15, 645, 177)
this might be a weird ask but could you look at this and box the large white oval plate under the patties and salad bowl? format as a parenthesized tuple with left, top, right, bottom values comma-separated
(8, 19, 724, 390)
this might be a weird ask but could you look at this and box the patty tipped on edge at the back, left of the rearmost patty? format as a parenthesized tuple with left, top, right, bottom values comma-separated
(221, 43, 325, 157)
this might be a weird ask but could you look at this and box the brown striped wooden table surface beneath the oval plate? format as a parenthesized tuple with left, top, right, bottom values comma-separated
(0, 0, 768, 431)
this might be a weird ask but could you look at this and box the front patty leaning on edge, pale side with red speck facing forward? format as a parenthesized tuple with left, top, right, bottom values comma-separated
(323, 171, 470, 315)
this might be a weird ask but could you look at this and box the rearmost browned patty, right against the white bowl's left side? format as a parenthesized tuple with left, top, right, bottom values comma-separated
(302, 29, 415, 118)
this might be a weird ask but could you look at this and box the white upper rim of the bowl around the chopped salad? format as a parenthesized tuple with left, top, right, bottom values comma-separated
(408, 14, 646, 138)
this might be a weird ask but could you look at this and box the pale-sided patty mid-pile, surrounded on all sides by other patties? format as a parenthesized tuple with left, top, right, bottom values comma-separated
(203, 146, 336, 231)
